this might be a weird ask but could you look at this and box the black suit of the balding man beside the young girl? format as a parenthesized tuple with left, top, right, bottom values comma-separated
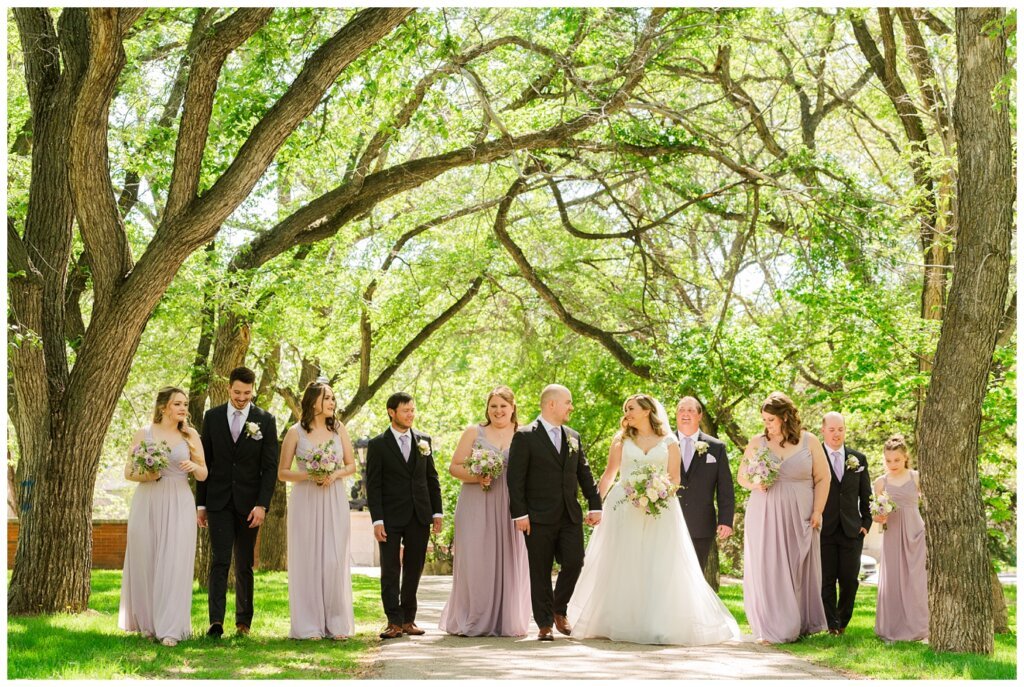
(821, 441, 871, 630)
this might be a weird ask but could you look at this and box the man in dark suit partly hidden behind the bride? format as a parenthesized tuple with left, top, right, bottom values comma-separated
(676, 396, 736, 570)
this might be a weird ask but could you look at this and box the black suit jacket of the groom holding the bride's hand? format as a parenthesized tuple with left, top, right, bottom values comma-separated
(506, 419, 601, 524)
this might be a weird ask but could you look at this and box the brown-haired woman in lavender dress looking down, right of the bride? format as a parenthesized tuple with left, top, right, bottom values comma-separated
(736, 391, 829, 644)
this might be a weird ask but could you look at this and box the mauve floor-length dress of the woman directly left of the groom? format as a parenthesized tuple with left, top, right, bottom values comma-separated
(437, 427, 530, 637)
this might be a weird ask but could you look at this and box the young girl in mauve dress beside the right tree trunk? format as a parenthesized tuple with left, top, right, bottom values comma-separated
(874, 434, 928, 642)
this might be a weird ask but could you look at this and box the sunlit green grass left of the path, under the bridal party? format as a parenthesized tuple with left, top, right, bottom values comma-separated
(7, 570, 384, 680)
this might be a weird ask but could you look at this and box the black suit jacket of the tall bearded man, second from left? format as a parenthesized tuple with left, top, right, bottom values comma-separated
(196, 403, 278, 514)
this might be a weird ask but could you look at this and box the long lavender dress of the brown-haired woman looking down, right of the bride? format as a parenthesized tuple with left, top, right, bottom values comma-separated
(743, 432, 828, 644)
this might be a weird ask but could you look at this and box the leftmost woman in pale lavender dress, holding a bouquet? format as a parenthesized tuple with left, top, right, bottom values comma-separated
(118, 386, 207, 646)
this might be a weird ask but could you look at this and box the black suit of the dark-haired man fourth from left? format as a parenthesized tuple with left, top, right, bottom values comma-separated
(367, 428, 441, 626)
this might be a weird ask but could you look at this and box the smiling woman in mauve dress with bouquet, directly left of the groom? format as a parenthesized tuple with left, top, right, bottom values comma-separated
(437, 386, 530, 637)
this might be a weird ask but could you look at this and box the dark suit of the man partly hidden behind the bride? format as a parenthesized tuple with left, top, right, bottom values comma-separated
(676, 432, 736, 570)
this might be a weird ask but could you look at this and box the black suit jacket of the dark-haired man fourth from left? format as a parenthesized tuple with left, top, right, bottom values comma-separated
(367, 427, 442, 527)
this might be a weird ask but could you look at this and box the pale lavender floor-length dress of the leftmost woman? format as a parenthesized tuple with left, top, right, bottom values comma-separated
(118, 426, 196, 641)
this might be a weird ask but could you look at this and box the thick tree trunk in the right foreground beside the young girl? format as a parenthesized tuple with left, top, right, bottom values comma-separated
(921, 7, 1014, 653)
